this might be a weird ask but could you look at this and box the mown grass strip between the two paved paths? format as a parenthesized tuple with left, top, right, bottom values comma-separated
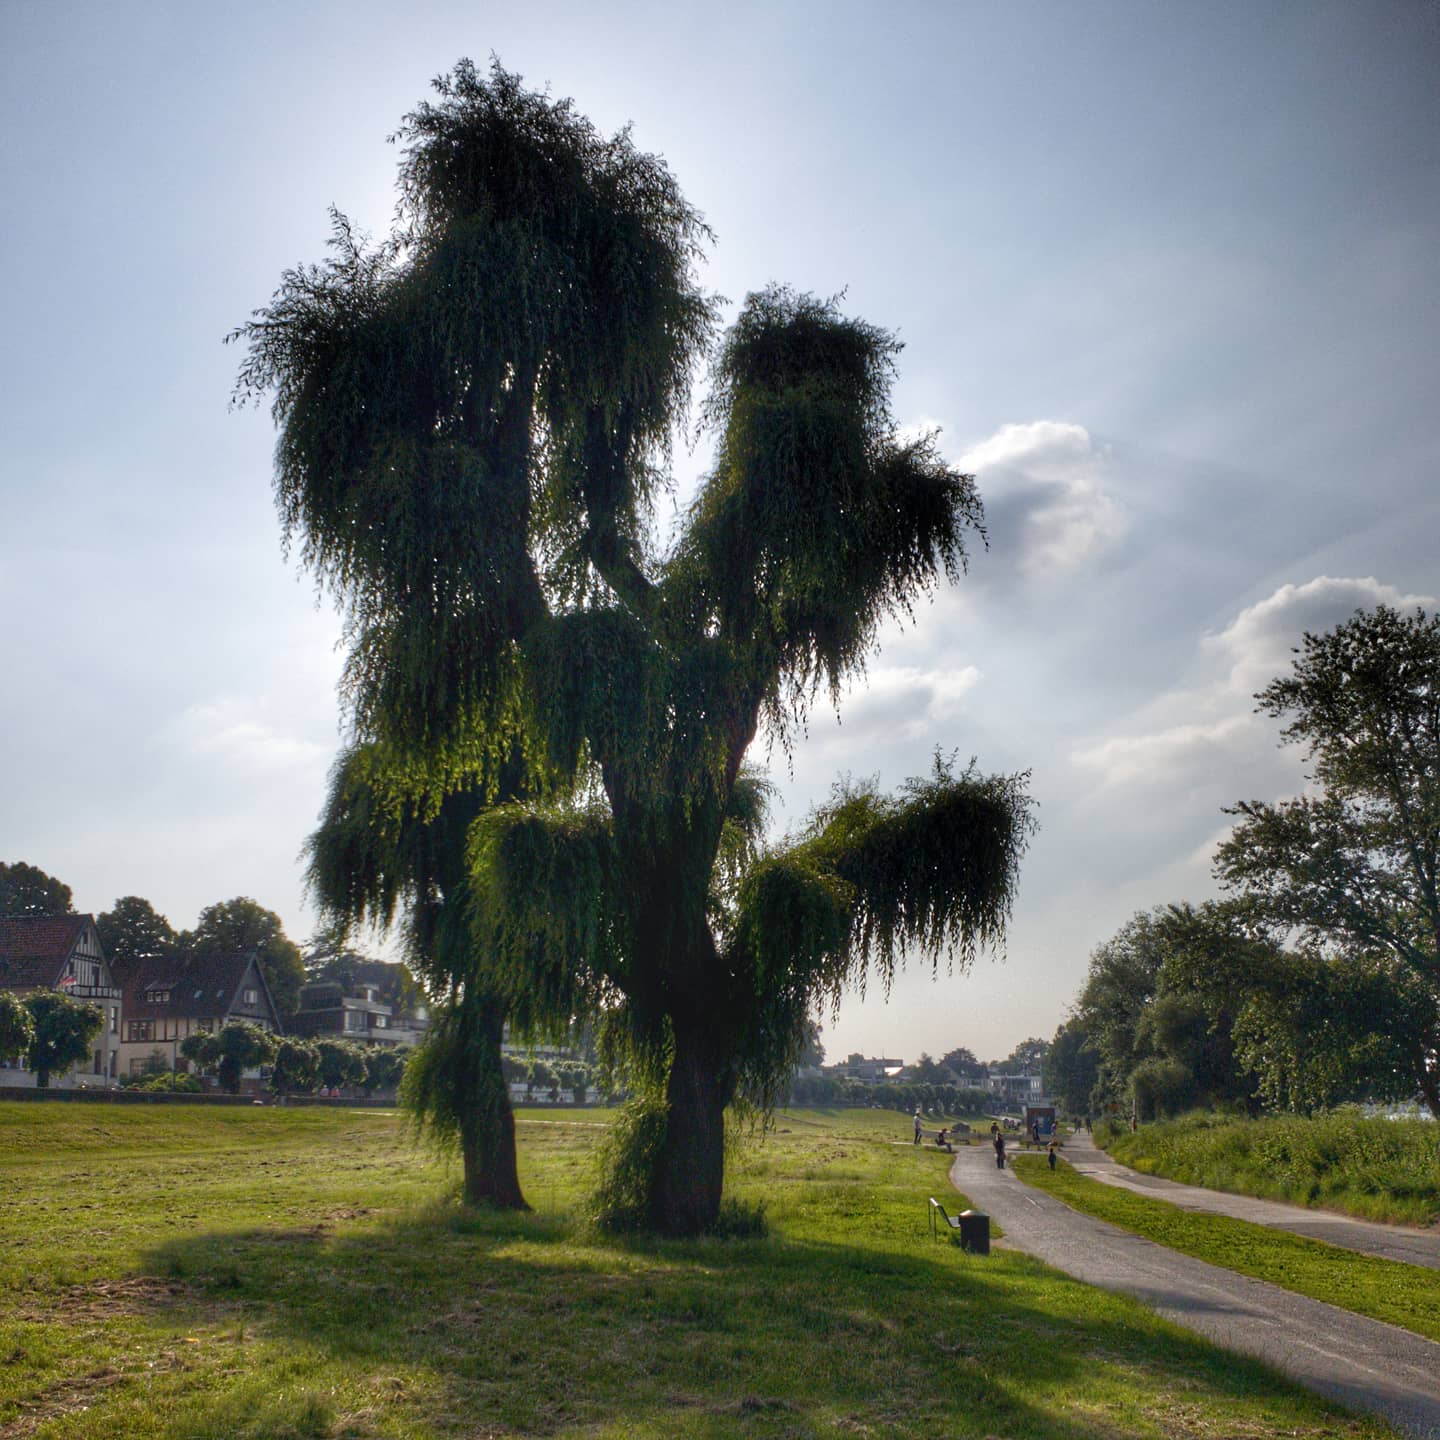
(1015, 1155, 1440, 1341)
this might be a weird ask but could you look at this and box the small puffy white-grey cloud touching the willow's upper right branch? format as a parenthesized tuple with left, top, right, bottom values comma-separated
(959, 420, 1129, 583)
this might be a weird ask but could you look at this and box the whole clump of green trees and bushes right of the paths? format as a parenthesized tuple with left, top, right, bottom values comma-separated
(1045, 606, 1440, 1119)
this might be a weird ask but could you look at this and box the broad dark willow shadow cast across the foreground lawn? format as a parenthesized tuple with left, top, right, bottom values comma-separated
(132, 1207, 1381, 1440)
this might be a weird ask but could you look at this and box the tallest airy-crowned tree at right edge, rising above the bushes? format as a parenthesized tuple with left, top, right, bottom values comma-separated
(1215, 605, 1440, 1116)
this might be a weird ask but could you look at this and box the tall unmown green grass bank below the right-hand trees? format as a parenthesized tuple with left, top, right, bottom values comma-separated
(1096, 1110, 1440, 1225)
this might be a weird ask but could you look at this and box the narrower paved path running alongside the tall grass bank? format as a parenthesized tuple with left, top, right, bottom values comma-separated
(1063, 1135, 1440, 1270)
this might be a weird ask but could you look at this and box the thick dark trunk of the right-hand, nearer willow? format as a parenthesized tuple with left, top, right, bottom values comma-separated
(649, 1021, 734, 1236)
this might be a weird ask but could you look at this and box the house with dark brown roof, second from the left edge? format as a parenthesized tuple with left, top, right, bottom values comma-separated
(115, 952, 284, 1079)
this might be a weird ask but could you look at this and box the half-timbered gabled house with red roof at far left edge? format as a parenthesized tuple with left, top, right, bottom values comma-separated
(0, 914, 121, 1090)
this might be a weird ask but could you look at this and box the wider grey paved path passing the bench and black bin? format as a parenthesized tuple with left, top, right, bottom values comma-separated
(950, 1145, 1440, 1440)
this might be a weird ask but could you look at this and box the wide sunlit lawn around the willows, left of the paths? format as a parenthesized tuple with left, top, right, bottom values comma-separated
(0, 1104, 1391, 1440)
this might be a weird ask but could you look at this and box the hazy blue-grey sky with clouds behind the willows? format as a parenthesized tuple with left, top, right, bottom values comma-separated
(0, 0, 1440, 1057)
